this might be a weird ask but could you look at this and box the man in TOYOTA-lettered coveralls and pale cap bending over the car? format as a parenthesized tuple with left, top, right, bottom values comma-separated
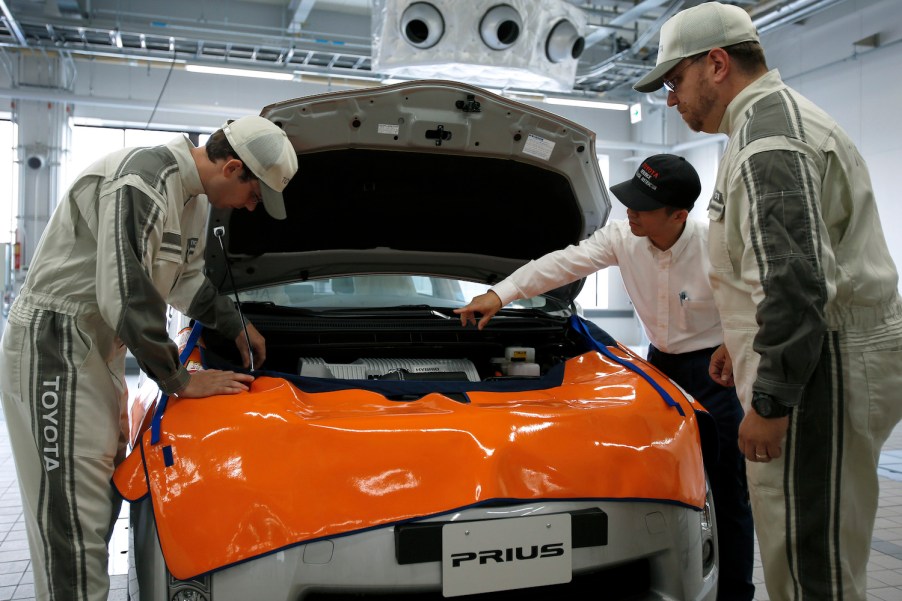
(0, 116, 298, 601)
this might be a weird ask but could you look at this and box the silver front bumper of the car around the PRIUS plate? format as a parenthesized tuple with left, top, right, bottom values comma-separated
(130, 495, 717, 601)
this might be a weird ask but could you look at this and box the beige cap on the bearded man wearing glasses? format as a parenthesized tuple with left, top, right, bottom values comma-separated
(633, 2, 761, 92)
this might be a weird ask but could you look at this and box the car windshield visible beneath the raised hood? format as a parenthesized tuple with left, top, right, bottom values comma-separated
(238, 275, 566, 312)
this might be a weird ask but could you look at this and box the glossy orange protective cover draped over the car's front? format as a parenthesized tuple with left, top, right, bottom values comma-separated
(113, 349, 706, 579)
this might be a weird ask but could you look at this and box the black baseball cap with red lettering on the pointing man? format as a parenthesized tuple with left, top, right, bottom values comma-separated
(611, 154, 702, 211)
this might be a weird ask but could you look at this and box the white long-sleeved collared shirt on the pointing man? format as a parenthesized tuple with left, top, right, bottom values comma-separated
(492, 219, 723, 354)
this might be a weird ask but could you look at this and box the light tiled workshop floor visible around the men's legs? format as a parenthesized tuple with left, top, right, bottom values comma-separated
(0, 382, 902, 601)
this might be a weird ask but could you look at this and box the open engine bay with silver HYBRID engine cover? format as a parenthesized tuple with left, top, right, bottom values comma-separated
(193, 314, 616, 382)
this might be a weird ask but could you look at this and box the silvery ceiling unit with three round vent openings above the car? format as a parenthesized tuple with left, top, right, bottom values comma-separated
(372, 0, 586, 92)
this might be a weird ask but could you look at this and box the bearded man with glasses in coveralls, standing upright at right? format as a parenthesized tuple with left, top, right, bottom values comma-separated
(634, 2, 902, 601)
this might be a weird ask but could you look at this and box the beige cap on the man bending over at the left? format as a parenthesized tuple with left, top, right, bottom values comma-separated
(222, 115, 298, 219)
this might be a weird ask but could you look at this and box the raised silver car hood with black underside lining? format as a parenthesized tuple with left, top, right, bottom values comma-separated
(206, 80, 610, 300)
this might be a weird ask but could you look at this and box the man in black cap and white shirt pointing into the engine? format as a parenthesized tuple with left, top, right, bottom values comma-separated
(455, 154, 755, 601)
